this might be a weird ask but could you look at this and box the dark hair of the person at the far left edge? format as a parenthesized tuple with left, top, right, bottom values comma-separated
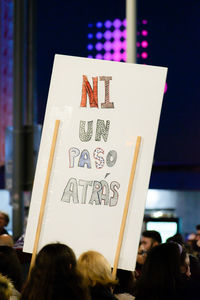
(0, 246, 22, 291)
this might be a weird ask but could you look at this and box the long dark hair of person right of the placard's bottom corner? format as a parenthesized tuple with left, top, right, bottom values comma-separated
(136, 243, 181, 300)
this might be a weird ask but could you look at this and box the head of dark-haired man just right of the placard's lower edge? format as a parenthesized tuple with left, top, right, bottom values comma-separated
(140, 230, 162, 251)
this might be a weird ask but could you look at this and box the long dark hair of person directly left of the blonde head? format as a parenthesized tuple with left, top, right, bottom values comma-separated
(20, 243, 87, 300)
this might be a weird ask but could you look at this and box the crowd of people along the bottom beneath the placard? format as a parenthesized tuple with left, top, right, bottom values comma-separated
(0, 212, 200, 300)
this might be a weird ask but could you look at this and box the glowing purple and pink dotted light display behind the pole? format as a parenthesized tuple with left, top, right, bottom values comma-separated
(87, 19, 149, 63)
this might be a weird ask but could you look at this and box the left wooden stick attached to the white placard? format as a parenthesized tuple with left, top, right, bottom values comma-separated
(29, 120, 60, 275)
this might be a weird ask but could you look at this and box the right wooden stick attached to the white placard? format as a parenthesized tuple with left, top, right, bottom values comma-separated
(112, 136, 141, 278)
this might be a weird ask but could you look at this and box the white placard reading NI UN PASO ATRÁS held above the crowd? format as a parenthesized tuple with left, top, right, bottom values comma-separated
(24, 55, 167, 270)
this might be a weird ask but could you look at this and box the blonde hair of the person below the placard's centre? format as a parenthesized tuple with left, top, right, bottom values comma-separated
(77, 251, 117, 286)
